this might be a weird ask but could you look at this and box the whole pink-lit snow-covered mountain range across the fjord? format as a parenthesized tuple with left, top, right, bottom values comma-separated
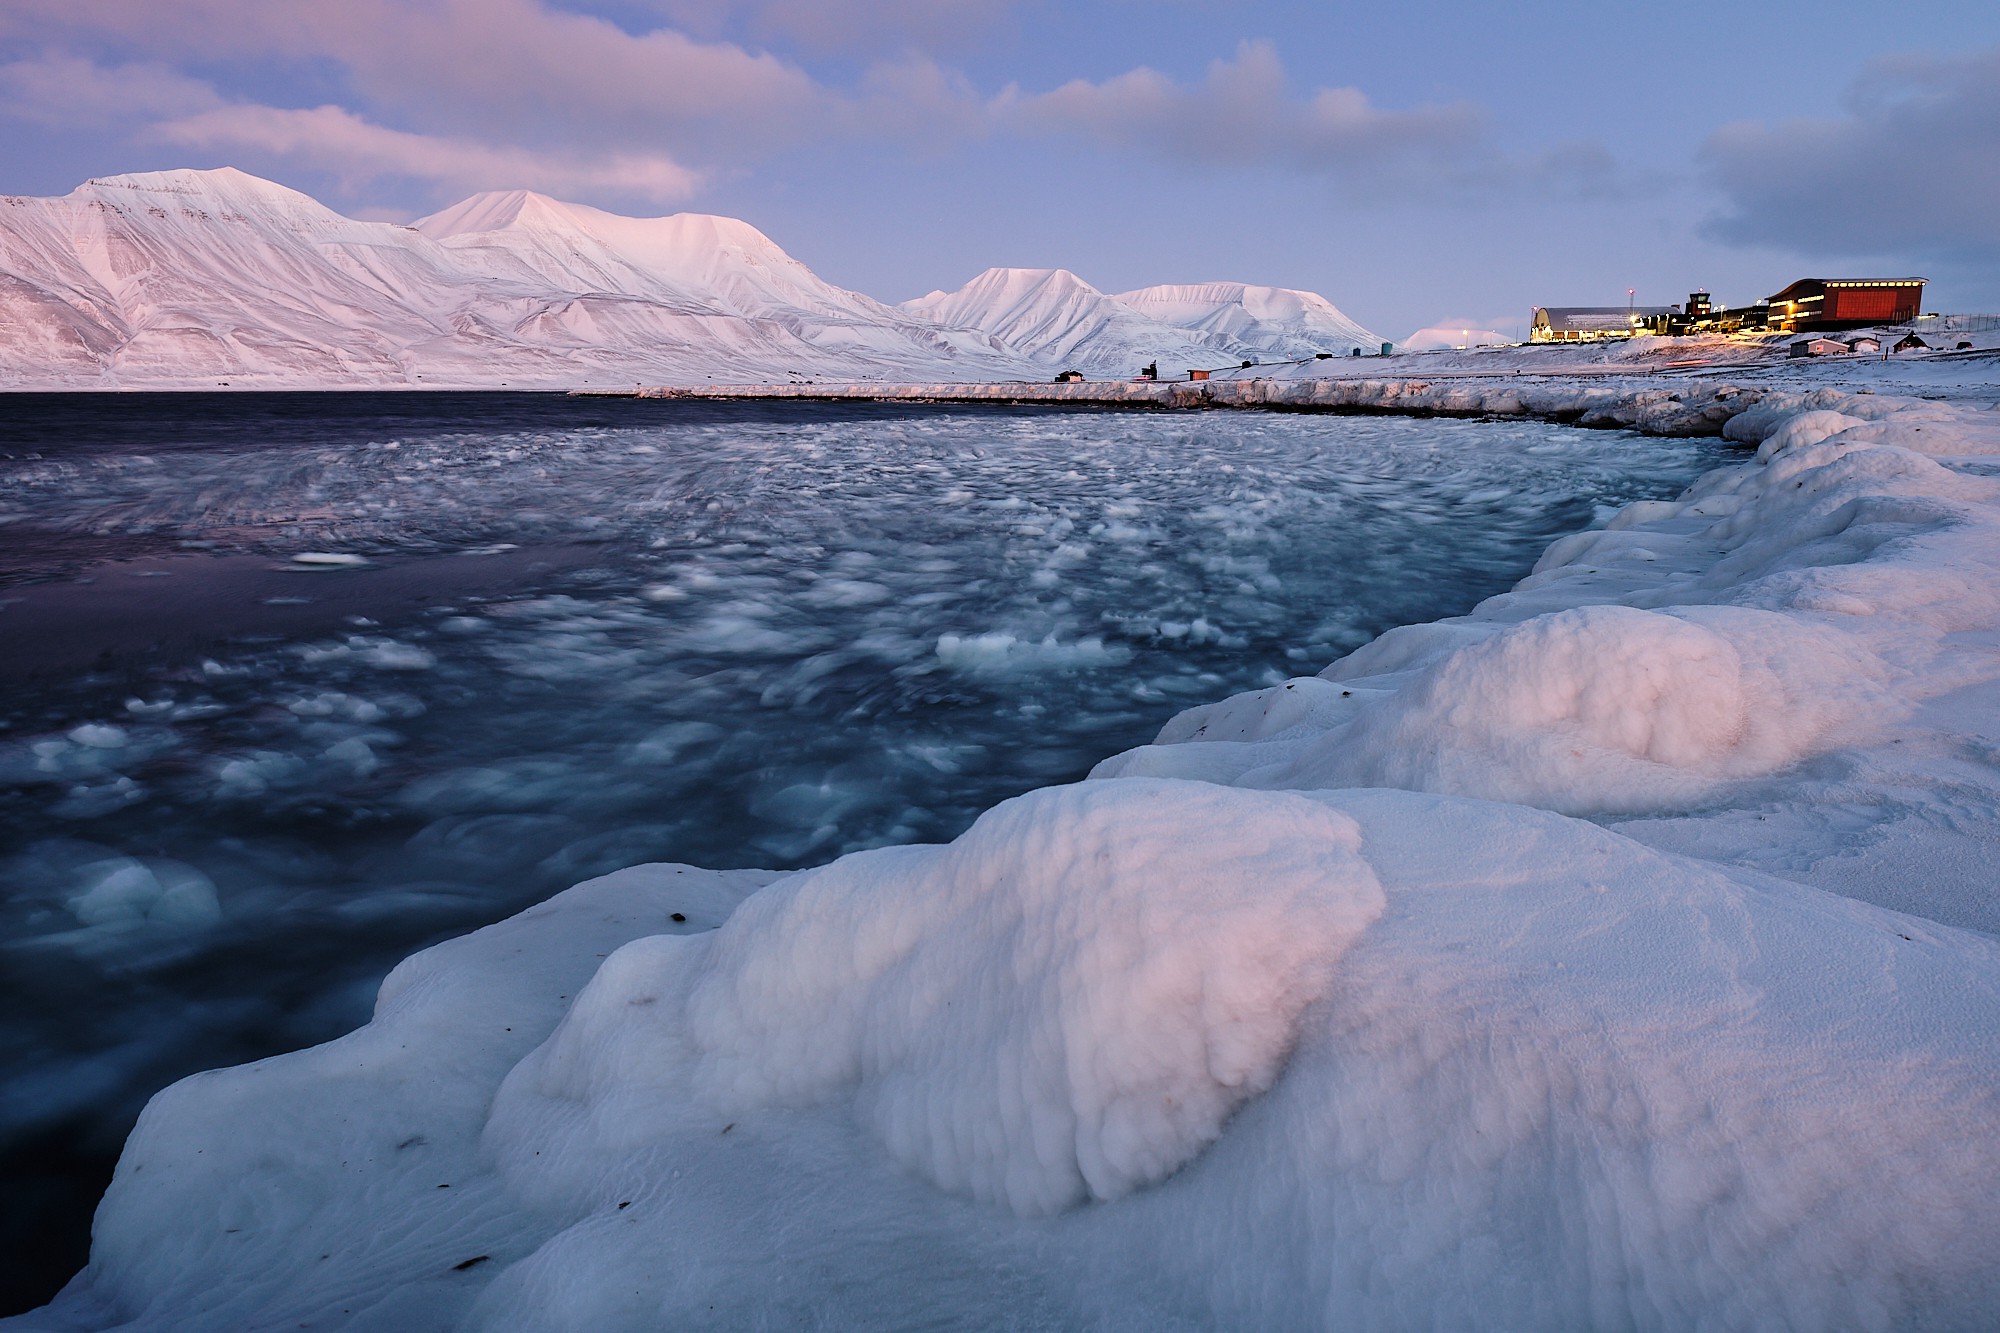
(0, 168, 1378, 388)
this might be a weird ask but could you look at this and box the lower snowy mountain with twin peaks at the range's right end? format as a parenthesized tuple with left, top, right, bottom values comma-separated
(902, 268, 1380, 374)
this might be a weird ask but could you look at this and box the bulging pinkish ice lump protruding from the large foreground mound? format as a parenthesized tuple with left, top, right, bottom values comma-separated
(486, 781, 1382, 1215)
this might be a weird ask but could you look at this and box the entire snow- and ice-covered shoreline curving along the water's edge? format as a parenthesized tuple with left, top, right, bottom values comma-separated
(18, 370, 2000, 1329)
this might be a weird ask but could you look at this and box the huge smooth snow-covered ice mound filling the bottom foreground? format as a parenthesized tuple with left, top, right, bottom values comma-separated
(27, 781, 2000, 1329)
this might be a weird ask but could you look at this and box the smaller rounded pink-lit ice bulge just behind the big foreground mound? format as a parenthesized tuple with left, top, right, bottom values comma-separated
(1270, 606, 1892, 815)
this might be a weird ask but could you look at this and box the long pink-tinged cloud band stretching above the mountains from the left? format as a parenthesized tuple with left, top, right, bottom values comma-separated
(0, 0, 1614, 198)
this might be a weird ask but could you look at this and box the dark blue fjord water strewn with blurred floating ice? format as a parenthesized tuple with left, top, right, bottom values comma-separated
(0, 394, 1722, 1305)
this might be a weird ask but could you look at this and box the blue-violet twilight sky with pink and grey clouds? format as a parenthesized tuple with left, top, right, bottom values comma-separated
(0, 0, 2000, 338)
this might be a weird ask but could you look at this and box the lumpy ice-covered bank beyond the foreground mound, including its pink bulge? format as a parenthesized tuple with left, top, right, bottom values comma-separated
(1096, 384, 2000, 815)
